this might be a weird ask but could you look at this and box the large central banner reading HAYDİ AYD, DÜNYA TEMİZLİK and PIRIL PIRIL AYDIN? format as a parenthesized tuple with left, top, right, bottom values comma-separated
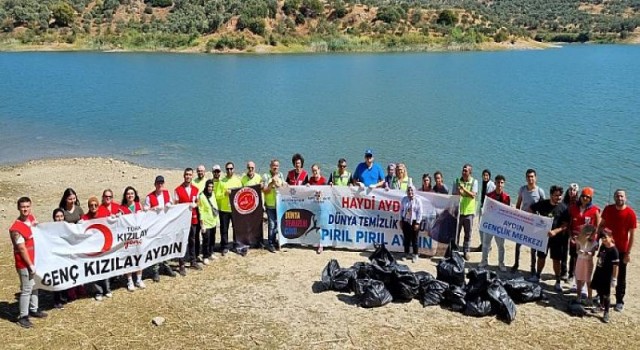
(277, 186, 460, 256)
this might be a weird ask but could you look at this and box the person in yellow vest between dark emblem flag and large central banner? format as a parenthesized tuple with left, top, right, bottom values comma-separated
(262, 159, 284, 253)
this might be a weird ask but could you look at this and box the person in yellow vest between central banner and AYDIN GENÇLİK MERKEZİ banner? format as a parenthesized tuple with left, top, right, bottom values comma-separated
(452, 164, 478, 260)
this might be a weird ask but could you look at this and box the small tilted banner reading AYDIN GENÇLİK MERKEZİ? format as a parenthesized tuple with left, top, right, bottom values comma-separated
(480, 197, 553, 252)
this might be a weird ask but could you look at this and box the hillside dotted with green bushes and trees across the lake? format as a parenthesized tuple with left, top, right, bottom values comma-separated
(0, 0, 640, 52)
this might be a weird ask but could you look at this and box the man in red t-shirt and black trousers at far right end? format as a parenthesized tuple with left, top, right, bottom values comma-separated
(598, 189, 638, 312)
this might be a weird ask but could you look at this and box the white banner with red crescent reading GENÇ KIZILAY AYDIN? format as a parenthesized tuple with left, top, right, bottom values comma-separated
(32, 204, 191, 290)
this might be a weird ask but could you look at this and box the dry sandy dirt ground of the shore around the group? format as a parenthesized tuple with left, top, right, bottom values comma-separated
(0, 158, 640, 350)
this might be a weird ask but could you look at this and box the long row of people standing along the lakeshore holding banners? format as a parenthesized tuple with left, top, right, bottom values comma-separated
(9, 149, 637, 328)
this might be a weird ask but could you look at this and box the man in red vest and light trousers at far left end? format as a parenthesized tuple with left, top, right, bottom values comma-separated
(9, 197, 47, 328)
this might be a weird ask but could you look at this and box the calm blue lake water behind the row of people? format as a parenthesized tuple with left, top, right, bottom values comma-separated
(0, 45, 640, 208)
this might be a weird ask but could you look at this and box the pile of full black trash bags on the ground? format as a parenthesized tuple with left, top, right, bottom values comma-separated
(321, 246, 543, 323)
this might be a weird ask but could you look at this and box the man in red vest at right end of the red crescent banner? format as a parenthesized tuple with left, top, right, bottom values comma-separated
(173, 168, 202, 276)
